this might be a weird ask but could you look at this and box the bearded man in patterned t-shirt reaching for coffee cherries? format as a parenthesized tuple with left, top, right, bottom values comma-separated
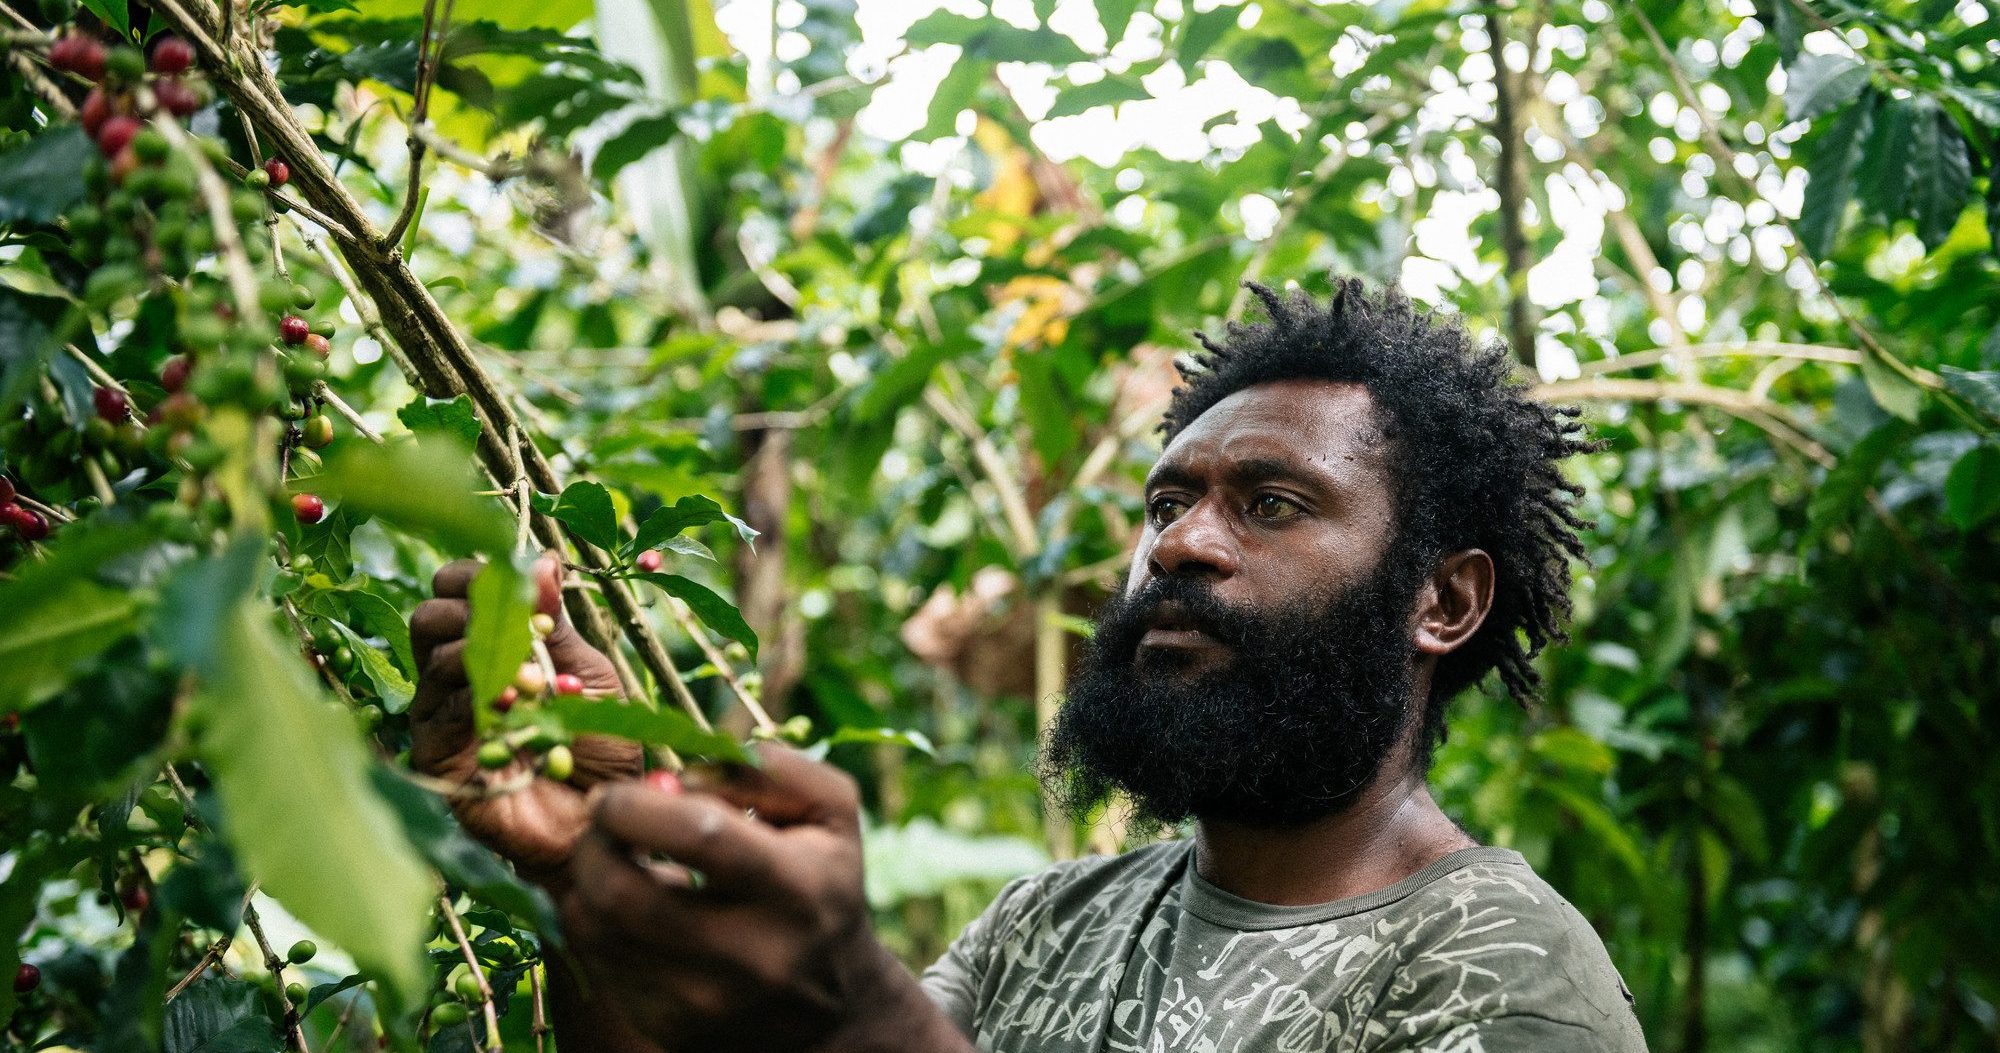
(414, 280, 1644, 1053)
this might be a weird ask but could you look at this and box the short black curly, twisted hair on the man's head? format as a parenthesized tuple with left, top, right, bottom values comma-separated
(1160, 276, 1600, 765)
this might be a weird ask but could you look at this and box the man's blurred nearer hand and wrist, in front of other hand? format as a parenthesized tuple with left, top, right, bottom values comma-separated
(560, 747, 964, 1051)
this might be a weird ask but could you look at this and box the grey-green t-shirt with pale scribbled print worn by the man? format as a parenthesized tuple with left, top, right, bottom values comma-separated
(924, 841, 1646, 1053)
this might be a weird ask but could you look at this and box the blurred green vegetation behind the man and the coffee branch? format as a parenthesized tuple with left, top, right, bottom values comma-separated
(3, 0, 2000, 1053)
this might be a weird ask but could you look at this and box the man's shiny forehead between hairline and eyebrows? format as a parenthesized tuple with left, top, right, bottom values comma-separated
(1160, 380, 1382, 476)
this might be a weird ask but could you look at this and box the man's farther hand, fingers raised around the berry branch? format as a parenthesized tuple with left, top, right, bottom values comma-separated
(410, 557, 644, 887)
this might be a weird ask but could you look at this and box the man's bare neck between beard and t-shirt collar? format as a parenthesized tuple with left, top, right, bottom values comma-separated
(1194, 773, 1476, 907)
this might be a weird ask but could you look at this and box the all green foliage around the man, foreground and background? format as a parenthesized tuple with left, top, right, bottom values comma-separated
(0, 0, 2000, 1053)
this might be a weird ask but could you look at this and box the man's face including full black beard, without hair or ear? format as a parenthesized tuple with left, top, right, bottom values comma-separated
(1044, 380, 1422, 825)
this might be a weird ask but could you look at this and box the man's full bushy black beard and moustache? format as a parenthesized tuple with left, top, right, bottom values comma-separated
(1040, 553, 1418, 827)
